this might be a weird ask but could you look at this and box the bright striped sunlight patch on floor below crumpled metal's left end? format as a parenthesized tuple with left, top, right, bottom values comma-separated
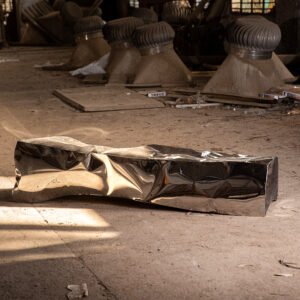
(0, 203, 119, 264)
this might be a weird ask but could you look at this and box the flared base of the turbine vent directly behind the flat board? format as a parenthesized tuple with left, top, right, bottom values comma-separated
(133, 47, 192, 85)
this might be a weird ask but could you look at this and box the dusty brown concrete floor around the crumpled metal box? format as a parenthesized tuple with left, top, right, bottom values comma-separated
(0, 48, 300, 300)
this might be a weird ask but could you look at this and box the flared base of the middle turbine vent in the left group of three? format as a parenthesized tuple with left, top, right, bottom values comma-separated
(106, 46, 141, 84)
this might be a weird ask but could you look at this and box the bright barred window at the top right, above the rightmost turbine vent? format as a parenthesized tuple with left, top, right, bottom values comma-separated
(231, 0, 275, 14)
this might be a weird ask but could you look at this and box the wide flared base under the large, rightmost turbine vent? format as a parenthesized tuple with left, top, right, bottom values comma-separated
(203, 53, 295, 98)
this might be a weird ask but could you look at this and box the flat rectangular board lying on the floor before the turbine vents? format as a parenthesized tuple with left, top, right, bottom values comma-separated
(53, 86, 165, 112)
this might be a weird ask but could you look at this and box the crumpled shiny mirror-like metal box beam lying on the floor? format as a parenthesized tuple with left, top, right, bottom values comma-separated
(13, 137, 278, 215)
